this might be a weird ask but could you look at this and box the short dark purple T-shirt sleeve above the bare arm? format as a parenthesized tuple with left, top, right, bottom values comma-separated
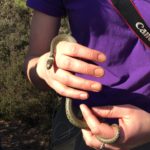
(27, 0, 65, 17)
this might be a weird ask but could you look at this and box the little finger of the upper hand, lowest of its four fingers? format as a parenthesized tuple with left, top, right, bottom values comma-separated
(49, 80, 88, 100)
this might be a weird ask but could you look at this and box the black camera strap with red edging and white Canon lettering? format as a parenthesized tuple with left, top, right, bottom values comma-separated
(110, 0, 150, 47)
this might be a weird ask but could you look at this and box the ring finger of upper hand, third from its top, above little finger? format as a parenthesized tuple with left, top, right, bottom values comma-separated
(54, 69, 102, 92)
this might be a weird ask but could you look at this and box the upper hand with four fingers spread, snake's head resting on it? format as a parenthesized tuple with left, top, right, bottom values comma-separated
(37, 41, 106, 100)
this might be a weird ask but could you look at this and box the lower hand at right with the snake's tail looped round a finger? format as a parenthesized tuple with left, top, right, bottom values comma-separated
(80, 104, 150, 150)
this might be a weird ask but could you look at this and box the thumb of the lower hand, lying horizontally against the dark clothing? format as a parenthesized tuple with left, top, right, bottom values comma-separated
(92, 105, 129, 118)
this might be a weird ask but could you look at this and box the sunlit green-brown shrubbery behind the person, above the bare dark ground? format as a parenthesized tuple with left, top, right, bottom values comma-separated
(0, 0, 66, 127)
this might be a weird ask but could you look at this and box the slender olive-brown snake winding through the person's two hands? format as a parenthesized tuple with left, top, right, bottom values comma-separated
(46, 34, 120, 144)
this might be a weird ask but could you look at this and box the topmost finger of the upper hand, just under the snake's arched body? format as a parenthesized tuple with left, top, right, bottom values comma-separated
(56, 41, 106, 62)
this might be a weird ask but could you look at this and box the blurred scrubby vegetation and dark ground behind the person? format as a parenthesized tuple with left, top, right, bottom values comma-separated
(0, 0, 68, 150)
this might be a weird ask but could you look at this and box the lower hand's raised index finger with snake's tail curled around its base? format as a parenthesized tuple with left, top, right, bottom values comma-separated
(80, 104, 115, 138)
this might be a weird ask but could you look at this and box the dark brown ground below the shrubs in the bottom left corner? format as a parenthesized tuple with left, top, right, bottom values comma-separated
(0, 121, 50, 150)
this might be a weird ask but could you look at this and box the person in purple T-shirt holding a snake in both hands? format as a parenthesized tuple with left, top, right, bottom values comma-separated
(24, 0, 150, 150)
